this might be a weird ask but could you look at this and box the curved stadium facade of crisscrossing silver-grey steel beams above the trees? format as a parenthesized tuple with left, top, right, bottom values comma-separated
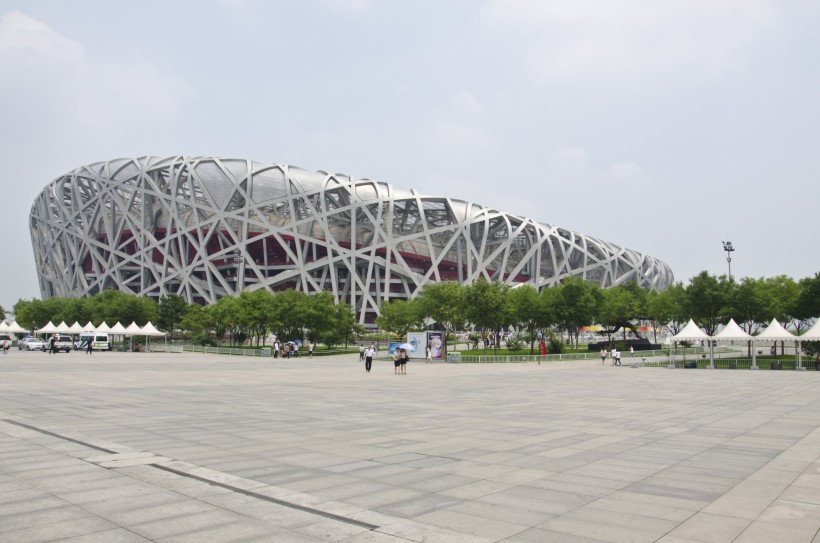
(30, 157, 673, 323)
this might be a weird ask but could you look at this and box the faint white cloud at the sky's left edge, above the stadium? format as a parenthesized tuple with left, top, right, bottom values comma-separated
(0, 12, 190, 134)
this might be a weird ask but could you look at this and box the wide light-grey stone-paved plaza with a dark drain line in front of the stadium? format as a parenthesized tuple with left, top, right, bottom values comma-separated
(0, 350, 820, 543)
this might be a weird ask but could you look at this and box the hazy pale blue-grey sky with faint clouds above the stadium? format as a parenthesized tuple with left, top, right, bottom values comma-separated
(0, 0, 820, 310)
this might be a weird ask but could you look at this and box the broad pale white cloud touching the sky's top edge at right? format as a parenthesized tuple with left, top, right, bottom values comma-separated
(482, 0, 778, 83)
